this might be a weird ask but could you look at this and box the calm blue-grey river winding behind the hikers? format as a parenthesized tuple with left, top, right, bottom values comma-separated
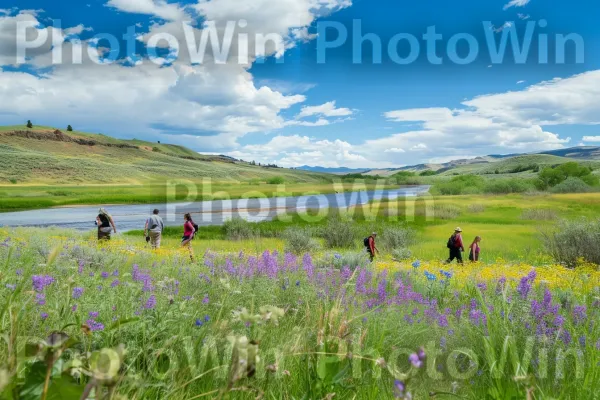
(0, 186, 429, 232)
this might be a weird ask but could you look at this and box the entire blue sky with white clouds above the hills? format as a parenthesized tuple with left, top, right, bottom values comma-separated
(0, 0, 600, 168)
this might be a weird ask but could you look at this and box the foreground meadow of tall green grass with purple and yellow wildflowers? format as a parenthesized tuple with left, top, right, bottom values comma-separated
(0, 223, 600, 399)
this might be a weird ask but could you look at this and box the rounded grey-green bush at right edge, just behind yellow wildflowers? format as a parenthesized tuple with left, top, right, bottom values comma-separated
(542, 218, 600, 268)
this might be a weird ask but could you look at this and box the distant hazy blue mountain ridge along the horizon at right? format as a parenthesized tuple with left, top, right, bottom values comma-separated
(297, 146, 600, 176)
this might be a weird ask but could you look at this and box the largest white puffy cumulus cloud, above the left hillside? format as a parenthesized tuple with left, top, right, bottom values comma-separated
(0, 0, 350, 151)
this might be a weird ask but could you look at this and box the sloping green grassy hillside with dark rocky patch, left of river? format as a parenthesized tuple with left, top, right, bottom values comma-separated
(0, 126, 326, 185)
